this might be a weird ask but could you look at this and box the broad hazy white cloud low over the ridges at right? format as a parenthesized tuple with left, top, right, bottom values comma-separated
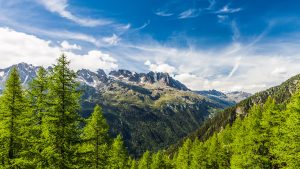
(119, 36, 300, 93)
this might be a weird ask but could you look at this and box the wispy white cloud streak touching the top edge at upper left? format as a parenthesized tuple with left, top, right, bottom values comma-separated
(38, 0, 111, 27)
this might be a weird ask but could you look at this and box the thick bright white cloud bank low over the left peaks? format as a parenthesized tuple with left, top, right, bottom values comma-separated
(0, 27, 118, 71)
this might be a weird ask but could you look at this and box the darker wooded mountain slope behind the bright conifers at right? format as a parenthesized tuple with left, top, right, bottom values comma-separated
(168, 74, 300, 153)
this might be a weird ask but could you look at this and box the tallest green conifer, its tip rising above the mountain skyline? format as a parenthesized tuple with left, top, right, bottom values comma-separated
(42, 54, 80, 169)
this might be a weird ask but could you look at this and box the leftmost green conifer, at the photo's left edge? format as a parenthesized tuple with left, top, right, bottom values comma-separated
(0, 67, 27, 168)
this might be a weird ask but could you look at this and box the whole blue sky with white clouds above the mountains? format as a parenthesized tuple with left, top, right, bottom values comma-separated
(0, 0, 300, 93)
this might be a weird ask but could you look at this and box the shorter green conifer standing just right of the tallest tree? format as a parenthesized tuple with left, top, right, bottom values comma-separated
(80, 105, 109, 169)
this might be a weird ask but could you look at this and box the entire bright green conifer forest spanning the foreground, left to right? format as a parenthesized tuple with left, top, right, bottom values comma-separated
(0, 55, 300, 169)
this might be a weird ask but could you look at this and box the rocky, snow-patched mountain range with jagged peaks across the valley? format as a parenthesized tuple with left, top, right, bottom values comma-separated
(0, 63, 239, 156)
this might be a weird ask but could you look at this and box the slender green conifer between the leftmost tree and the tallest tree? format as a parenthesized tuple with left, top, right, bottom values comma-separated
(22, 67, 49, 168)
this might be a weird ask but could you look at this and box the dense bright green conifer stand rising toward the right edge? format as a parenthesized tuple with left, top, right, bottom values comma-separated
(164, 92, 300, 169)
